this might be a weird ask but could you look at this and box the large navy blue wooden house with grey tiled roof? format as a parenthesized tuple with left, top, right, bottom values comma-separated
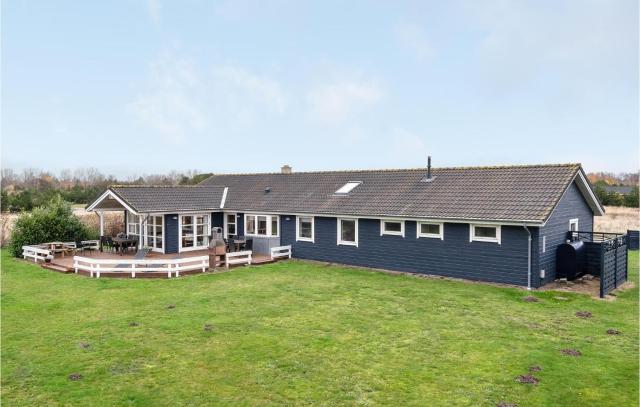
(88, 164, 604, 287)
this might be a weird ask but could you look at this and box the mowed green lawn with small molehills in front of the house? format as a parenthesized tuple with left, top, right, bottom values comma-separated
(2, 252, 638, 407)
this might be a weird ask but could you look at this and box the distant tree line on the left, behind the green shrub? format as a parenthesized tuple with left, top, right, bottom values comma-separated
(0, 168, 211, 212)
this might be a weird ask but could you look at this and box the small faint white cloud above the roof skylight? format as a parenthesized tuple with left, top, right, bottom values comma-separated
(307, 80, 383, 123)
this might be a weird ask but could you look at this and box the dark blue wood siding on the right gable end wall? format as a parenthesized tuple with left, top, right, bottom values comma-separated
(533, 182, 593, 287)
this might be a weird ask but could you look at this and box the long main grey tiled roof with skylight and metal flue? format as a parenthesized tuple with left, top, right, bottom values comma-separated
(201, 164, 582, 223)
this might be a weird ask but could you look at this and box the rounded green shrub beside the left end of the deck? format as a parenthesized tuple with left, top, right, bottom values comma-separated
(9, 195, 98, 257)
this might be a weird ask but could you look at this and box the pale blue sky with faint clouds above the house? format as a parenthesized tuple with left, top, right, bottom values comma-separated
(1, 0, 639, 177)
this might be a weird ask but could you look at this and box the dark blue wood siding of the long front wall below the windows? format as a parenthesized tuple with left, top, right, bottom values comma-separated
(280, 215, 528, 286)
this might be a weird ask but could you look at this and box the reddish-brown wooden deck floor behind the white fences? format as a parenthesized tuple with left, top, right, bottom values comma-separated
(48, 250, 277, 273)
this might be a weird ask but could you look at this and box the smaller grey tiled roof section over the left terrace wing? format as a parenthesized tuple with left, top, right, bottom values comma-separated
(109, 185, 224, 212)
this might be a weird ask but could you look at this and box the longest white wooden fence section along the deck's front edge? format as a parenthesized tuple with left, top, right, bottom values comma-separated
(73, 256, 209, 278)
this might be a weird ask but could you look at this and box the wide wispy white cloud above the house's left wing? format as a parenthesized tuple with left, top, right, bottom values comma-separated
(127, 53, 288, 142)
